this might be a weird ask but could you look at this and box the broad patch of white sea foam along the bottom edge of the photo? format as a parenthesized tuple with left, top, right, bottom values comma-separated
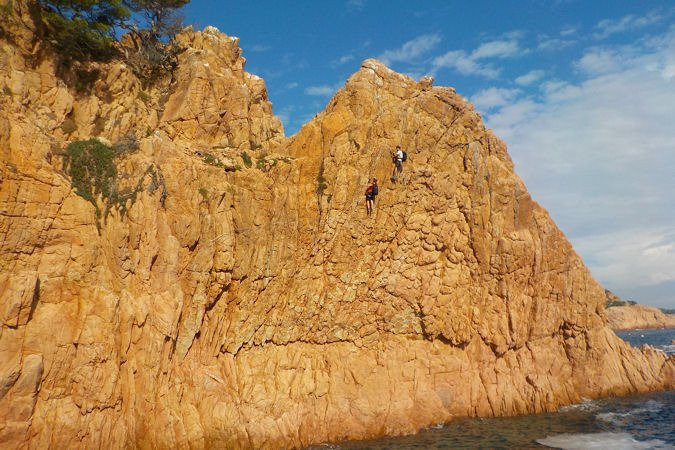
(537, 432, 673, 450)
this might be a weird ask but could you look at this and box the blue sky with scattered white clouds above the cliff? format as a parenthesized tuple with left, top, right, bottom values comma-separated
(184, 0, 675, 308)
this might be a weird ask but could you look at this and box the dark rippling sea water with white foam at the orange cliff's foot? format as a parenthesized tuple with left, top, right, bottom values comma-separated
(313, 329, 675, 450)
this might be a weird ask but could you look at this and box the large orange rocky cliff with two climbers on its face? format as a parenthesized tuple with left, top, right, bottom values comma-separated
(0, 7, 675, 448)
